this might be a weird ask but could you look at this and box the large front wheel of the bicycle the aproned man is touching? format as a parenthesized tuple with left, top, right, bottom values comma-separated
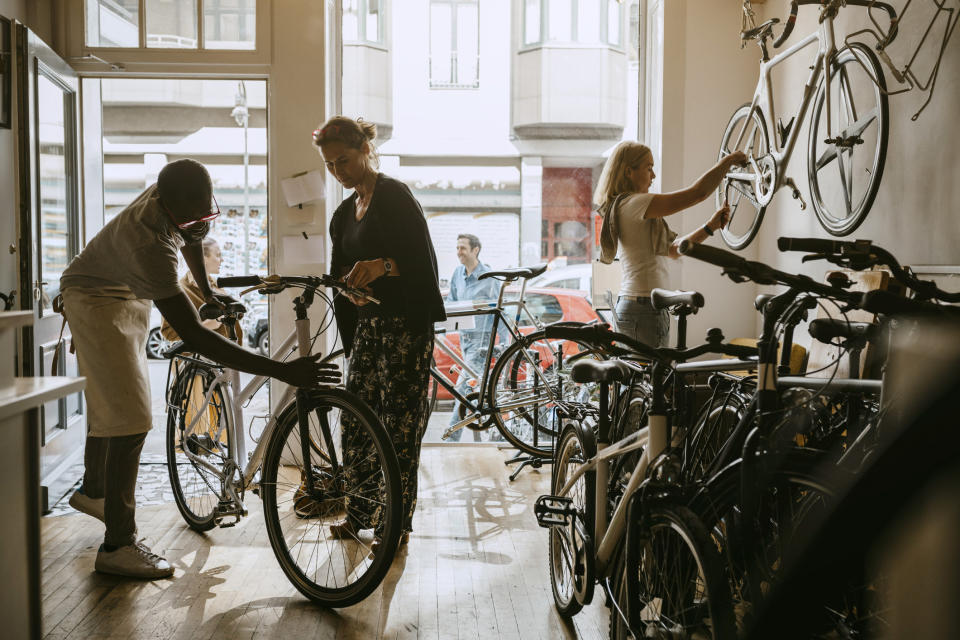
(261, 388, 403, 607)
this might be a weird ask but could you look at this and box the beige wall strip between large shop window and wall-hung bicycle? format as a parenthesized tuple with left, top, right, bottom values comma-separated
(654, 0, 759, 344)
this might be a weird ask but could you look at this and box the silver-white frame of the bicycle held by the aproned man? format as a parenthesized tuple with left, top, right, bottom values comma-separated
(172, 318, 311, 513)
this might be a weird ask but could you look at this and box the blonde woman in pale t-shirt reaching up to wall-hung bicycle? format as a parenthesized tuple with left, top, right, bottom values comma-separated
(593, 141, 746, 347)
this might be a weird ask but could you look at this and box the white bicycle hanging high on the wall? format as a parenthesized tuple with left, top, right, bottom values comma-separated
(717, 0, 897, 249)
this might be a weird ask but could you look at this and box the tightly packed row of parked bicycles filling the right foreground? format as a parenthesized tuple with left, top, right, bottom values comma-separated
(535, 238, 960, 640)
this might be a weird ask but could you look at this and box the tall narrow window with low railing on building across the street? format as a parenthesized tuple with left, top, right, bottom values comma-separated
(429, 0, 480, 89)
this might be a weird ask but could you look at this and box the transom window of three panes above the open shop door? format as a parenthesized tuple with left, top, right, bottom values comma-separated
(84, 0, 256, 50)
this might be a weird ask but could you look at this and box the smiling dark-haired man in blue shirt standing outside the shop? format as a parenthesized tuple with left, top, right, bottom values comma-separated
(446, 233, 510, 442)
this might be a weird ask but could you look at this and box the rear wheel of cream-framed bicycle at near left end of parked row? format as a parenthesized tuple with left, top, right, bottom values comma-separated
(547, 424, 596, 618)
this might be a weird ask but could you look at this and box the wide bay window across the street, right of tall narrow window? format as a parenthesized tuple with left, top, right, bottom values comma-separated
(523, 0, 622, 46)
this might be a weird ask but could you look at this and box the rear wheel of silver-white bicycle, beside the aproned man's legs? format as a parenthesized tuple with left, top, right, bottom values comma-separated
(166, 363, 233, 532)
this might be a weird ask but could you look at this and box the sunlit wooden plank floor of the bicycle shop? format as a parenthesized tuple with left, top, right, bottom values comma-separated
(41, 446, 608, 640)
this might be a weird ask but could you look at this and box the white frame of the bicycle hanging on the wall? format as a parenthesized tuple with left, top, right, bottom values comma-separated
(727, 11, 837, 206)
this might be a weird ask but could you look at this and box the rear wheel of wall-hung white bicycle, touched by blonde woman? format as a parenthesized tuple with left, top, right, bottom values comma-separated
(716, 102, 772, 251)
